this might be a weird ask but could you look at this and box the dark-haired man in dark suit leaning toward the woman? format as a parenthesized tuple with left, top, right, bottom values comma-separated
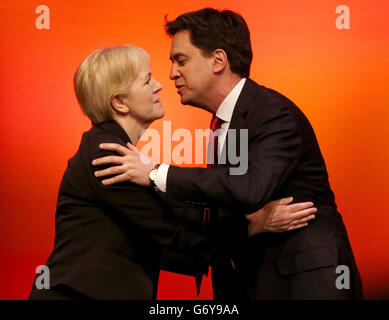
(92, 8, 363, 299)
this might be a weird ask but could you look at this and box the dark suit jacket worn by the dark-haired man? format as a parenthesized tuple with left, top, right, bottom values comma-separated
(166, 79, 362, 299)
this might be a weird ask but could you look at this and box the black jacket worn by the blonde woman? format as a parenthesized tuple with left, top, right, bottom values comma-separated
(31, 121, 247, 299)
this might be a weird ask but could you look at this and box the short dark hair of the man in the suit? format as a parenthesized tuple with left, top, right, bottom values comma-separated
(165, 8, 253, 77)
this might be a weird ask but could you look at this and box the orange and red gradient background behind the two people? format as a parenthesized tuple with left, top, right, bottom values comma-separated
(0, 0, 389, 299)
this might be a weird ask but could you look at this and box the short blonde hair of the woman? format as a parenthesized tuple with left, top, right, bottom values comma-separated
(74, 45, 149, 124)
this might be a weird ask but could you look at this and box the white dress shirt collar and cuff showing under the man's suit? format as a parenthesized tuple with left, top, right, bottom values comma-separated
(154, 78, 246, 192)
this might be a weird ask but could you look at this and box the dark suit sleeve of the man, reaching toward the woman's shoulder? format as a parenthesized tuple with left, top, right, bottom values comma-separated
(167, 105, 301, 213)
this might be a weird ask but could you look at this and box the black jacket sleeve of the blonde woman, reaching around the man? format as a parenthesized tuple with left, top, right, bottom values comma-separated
(82, 131, 247, 253)
